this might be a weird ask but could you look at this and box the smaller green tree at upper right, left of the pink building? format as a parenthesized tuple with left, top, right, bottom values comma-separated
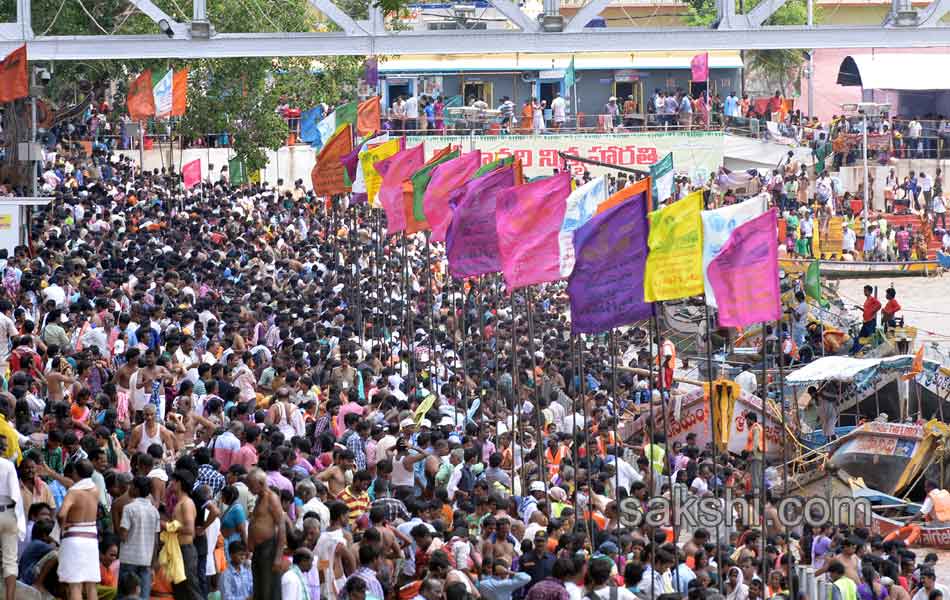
(686, 0, 817, 95)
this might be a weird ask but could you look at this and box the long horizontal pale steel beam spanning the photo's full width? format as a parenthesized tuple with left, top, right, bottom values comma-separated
(0, 26, 950, 60)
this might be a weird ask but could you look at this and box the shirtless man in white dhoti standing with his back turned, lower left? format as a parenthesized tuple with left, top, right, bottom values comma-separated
(56, 460, 100, 600)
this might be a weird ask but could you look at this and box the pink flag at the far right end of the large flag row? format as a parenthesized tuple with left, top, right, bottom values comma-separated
(706, 208, 782, 327)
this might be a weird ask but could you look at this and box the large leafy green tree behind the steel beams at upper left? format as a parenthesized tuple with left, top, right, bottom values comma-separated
(19, 0, 369, 170)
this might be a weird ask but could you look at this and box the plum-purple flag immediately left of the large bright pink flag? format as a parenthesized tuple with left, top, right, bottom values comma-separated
(445, 167, 515, 278)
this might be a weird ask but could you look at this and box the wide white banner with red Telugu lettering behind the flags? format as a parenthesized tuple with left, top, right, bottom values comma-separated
(407, 131, 725, 180)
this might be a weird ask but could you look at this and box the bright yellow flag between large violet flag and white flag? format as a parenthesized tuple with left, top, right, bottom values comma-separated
(644, 190, 703, 302)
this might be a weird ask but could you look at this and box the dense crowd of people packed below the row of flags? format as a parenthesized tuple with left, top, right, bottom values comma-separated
(0, 105, 950, 600)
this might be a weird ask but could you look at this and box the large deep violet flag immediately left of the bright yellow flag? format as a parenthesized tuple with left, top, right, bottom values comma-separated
(567, 193, 653, 333)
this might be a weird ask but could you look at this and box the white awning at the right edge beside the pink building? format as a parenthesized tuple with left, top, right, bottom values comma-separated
(838, 54, 950, 90)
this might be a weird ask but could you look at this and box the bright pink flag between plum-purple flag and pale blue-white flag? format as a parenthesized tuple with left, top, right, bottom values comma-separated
(495, 173, 571, 292)
